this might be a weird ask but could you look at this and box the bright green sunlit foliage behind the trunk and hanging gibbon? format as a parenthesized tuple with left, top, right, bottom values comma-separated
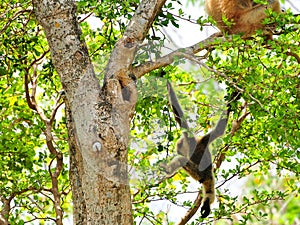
(0, 0, 300, 224)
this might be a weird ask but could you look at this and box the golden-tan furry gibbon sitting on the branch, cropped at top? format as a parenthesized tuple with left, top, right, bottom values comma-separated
(205, 0, 281, 38)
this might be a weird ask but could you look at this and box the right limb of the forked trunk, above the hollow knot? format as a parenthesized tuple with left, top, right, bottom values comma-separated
(105, 0, 166, 90)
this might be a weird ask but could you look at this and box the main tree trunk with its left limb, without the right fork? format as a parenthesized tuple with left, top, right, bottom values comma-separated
(34, 0, 132, 224)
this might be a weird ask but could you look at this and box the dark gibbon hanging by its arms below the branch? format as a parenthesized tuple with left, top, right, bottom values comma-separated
(161, 82, 233, 218)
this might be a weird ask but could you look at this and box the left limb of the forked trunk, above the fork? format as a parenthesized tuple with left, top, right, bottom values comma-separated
(33, 0, 100, 98)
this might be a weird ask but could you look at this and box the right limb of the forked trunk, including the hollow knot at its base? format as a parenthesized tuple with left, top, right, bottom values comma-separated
(103, 0, 166, 133)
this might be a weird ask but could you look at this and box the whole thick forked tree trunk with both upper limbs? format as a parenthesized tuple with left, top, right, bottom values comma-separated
(33, 0, 165, 225)
